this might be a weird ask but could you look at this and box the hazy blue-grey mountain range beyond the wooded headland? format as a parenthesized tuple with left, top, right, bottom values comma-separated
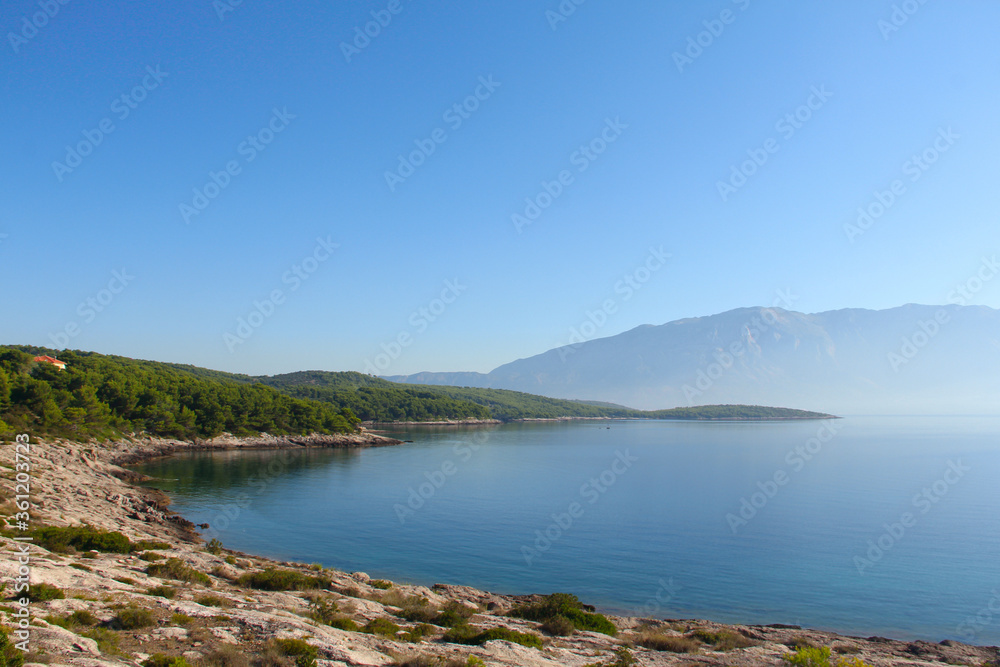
(385, 304, 1000, 414)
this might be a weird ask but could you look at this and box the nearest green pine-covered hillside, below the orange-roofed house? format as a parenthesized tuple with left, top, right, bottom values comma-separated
(0, 346, 360, 439)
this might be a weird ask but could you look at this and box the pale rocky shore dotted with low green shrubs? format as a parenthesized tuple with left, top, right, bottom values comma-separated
(0, 434, 998, 667)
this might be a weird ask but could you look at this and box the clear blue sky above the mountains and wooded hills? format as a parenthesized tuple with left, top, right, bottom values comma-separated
(0, 0, 1000, 374)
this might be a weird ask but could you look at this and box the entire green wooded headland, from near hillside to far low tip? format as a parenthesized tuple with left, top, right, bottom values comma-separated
(0, 346, 827, 439)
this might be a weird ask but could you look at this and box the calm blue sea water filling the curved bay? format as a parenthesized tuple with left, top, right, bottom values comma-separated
(141, 417, 1000, 644)
